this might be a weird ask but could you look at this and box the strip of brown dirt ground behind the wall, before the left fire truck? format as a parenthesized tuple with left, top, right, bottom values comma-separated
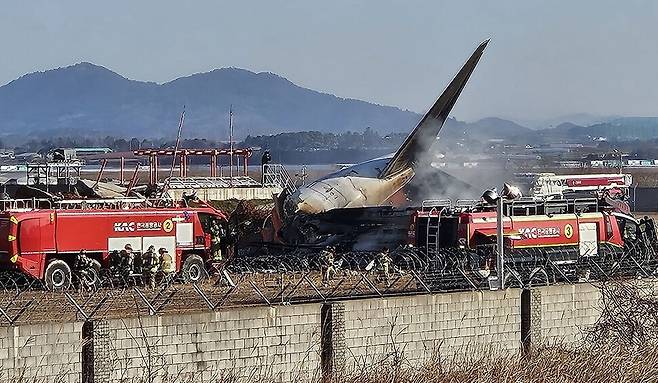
(0, 272, 422, 326)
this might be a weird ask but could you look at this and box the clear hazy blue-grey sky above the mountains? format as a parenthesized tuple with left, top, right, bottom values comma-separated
(0, 0, 658, 120)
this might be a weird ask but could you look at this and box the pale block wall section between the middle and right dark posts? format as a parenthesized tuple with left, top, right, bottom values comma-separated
(336, 290, 521, 371)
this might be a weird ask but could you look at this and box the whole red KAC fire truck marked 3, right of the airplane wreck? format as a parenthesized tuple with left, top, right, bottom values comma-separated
(407, 198, 658, 284)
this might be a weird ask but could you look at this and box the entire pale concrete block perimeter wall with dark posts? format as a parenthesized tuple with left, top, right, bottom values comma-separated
(0, 284, 632, 382)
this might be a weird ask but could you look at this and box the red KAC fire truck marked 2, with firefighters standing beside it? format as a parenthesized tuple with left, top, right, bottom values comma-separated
(0, 200, 227, 288)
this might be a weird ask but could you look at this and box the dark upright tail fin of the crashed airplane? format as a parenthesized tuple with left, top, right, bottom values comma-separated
(379, 40, 489, 178)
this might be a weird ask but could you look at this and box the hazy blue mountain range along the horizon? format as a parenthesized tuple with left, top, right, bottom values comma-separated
(0, 62, 658, 143)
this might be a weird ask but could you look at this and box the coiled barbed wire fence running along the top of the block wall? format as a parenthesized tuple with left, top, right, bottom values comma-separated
(0, 242, 658, 326)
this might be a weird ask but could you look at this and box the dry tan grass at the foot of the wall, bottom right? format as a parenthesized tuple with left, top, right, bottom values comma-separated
(331, 344, 658, 383)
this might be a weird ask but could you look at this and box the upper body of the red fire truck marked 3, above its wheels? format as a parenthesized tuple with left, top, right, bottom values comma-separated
(409, 200, 624, 250)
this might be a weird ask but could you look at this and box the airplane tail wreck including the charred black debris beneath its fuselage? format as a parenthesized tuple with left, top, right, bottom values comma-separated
(272, 40, 489, 249)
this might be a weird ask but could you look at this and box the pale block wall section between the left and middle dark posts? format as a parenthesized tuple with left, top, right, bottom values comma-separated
(100, 304, 320, 382)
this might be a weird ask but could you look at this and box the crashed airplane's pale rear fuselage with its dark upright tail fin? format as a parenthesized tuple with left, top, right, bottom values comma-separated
(273, 40, 489, 248)
